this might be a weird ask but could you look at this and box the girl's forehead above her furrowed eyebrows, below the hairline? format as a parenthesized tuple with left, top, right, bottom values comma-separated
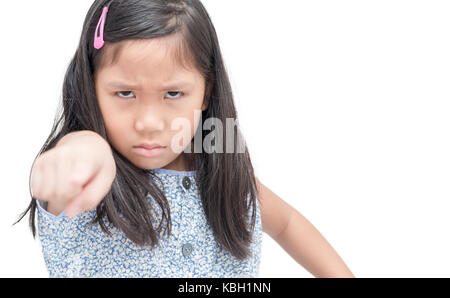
(96, 36, 200, 80)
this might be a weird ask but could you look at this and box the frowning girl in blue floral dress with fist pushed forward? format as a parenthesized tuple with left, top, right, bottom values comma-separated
(15, 0, 352, 277)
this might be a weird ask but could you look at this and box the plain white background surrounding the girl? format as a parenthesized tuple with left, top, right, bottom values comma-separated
(0, 0, 450, 277)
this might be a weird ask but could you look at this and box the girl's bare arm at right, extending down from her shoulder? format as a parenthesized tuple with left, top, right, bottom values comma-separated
(256, 179, 355, 277)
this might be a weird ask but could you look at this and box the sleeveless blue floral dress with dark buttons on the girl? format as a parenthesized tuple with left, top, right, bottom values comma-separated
(37, 168, 262, 277)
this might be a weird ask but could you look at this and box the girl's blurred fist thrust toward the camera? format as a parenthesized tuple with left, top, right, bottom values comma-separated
(31, 130, 116, 217)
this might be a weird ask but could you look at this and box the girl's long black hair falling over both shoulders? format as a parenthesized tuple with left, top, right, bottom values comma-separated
(16, 0, 257, 259)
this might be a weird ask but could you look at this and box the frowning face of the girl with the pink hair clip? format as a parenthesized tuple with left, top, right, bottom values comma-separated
(95, 39, 207, 170)
